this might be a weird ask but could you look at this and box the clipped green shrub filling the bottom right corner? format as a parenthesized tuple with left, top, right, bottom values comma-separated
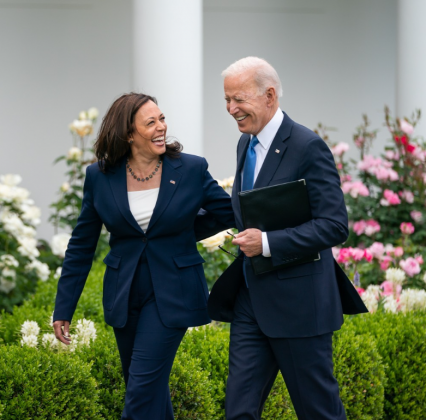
(350, 311, 426, 420)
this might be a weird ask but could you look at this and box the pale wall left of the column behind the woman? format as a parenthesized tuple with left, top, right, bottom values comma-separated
(0, 0, 132, 239)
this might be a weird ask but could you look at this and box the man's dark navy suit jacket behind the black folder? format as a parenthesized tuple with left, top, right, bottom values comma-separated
(232, 114, 348, 337)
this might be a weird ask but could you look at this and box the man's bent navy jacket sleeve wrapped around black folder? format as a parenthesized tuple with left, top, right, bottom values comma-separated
(267, 137, 348, 265)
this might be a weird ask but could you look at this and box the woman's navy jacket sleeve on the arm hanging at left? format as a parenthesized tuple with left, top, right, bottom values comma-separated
(53, 168, 102, 322)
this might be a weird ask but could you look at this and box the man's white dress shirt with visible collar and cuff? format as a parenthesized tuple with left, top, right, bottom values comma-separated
(241, 107, 284, 257)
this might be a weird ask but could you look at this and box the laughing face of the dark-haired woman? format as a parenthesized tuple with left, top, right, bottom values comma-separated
(132, 101, 167, 157)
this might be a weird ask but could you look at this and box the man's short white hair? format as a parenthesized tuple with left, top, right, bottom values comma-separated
(222, 57, 283, 98)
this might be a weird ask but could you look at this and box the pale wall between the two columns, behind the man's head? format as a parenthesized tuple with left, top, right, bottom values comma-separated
(204, 0, 397, 178)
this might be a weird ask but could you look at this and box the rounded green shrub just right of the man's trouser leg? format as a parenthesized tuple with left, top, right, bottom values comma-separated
(333, 323, 386, 420)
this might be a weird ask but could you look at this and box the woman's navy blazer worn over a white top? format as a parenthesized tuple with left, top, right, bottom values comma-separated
(53, 153, 235, 328)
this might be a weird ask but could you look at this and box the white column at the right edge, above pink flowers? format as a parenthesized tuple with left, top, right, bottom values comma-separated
(396, 0, 426, 137)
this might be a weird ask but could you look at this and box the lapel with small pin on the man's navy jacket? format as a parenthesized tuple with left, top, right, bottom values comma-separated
(254, 113, 294, 188)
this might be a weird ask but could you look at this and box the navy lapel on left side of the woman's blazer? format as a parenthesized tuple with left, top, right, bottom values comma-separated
(108, 158, 143, 234)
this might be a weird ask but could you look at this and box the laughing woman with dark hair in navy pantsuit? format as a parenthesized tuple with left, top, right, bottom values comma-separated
(53, 93, 235, 420)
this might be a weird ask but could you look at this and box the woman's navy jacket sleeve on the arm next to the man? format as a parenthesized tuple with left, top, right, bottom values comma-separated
(194, 158, 236, 241)
